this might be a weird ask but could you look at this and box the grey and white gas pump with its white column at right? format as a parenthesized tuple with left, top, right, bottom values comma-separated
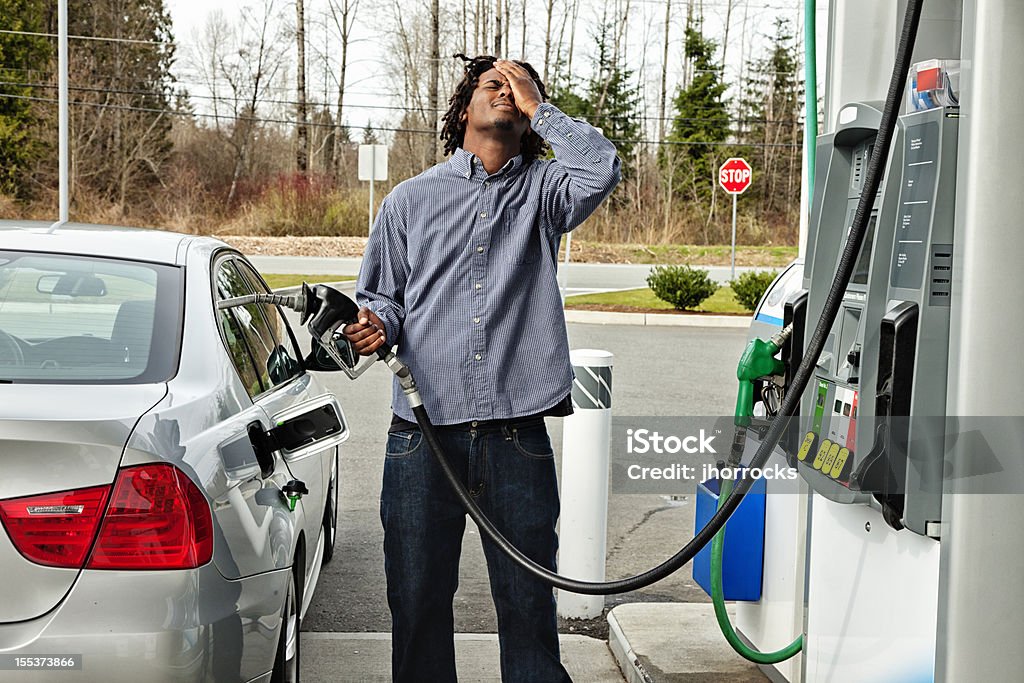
(736, 0, 1024, 681)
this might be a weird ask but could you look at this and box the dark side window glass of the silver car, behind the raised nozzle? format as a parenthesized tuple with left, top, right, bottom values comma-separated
(216, 259, 301, 397)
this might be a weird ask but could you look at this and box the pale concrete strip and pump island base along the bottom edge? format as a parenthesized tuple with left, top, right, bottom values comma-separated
(302, 603, 768, 683)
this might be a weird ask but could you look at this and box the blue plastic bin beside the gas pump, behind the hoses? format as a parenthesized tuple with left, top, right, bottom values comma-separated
(693, 478, 765, 601)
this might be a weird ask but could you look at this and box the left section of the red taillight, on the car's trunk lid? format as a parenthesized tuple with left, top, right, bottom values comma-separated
(0, 486, 111, 569)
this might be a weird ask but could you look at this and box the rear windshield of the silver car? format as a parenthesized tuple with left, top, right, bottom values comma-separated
(0, 251, 181, 384)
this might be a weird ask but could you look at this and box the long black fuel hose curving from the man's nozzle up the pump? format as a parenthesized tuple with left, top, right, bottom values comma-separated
(403, 0, 923, 595)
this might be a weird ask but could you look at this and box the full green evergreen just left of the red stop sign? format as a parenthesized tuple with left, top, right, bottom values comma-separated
(662, 23, 730, 196)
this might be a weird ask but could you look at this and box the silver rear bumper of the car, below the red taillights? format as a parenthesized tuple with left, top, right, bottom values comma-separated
(0, 563, 289, 683)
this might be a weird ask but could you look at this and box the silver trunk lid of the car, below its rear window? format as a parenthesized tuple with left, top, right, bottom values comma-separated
(0, 384, 167, 623)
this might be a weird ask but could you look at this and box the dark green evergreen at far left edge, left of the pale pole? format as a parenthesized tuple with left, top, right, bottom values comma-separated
(0, 0, 50, 199)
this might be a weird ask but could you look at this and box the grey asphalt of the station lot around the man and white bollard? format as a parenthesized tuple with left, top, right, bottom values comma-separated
(292, 325, 745, 637)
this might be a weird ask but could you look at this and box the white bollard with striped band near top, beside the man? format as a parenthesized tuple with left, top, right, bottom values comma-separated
(558, 349, 614, 618)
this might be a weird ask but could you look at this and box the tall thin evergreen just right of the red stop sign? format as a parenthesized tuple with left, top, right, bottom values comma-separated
(739, 17, 803, 222)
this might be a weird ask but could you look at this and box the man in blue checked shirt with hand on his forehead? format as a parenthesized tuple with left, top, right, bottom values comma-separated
(343, 55, 620, 683)
